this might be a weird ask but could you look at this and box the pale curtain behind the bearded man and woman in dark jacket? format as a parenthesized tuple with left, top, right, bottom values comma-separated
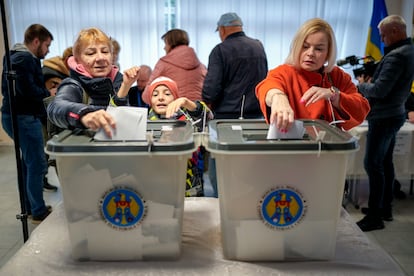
(7, 0, 165, 70)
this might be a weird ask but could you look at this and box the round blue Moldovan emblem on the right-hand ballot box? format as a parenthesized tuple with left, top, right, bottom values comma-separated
(259, 187, 306, 229)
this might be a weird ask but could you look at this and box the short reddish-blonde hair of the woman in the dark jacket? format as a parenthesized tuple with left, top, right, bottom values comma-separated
(73, 27, 113, 60)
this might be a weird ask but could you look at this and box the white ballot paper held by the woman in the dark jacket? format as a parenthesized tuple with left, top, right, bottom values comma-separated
(94, 106, 148, 141)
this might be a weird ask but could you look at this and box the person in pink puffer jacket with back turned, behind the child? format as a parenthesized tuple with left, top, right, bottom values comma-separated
(142, 29, 207, 104)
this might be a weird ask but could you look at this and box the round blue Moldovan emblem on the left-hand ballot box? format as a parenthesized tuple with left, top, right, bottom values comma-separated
(100, 188, 146, 230)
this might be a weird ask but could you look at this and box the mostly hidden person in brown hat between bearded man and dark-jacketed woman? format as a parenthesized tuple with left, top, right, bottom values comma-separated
(42, 56, 69, 191)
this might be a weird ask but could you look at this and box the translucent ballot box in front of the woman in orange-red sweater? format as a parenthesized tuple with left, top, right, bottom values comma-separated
(207, 120, 358, 261)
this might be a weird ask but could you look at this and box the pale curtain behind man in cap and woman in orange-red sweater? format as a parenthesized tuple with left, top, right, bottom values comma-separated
(178, 0, 372, 68)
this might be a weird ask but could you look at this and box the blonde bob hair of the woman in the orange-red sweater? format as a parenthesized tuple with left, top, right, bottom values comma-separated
(286, 18, 336, 72)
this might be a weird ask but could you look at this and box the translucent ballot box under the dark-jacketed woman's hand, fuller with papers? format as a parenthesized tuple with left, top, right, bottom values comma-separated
(46, 120, 195, 261)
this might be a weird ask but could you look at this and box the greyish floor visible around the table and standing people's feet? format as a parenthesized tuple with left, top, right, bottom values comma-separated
(0, 145, 414, 276)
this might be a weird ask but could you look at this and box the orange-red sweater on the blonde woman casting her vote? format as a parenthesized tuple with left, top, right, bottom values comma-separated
(256, 64, 370, 130)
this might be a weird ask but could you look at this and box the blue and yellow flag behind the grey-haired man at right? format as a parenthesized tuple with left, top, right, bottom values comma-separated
(365, 0, 388, 60)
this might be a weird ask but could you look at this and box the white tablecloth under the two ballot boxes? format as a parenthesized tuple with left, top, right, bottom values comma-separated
(0, 198, 404, 276)
